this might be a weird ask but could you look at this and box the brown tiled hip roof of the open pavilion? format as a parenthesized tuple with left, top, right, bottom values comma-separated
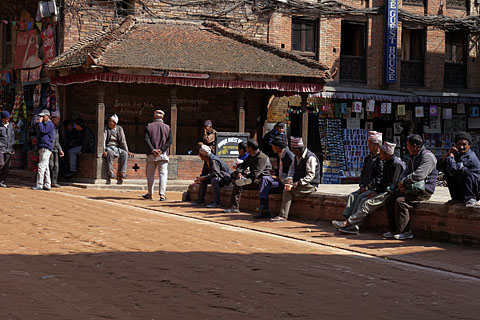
(48, 19, 329, 79)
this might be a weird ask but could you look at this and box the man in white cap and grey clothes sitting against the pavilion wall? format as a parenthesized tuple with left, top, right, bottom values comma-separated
(103, 114, 133, 184)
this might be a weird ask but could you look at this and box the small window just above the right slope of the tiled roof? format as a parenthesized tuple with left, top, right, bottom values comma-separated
(292, 18, 318, 57)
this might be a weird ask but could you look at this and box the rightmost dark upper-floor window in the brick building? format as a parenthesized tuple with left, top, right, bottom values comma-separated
(444, 31, 468, 88)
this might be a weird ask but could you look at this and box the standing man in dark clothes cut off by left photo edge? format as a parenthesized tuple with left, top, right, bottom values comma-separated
(0, 111, 15, 188)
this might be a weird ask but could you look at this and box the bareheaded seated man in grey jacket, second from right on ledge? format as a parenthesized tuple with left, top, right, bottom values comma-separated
(383, 134, 438, 240)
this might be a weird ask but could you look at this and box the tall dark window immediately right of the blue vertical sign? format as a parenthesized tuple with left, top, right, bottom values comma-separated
(400, 28, 425, 86)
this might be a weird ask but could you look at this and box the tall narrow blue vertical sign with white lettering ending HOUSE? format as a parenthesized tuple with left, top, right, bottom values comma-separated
(384, 0, 398, 83)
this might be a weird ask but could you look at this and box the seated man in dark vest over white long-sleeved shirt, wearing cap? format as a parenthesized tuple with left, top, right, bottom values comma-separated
(269, 137, 320, 222)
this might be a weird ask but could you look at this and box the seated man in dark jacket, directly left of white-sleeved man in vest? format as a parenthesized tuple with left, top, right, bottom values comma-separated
(254, 136, 295, 219)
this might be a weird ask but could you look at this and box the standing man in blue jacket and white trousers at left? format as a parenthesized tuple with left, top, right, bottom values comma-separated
(32, 109, 55, 191)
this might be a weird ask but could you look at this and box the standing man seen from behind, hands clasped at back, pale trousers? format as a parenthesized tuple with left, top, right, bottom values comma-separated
(142, 110, 172, 201)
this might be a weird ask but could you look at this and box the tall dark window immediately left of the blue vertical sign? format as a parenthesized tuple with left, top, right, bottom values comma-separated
(340, 21, 366, 82)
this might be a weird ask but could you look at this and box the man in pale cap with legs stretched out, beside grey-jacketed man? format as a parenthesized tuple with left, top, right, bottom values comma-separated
(332, 141, 405, 234)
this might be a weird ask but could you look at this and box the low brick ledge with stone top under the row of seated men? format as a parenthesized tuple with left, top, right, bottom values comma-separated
(188, 185, 480, 244)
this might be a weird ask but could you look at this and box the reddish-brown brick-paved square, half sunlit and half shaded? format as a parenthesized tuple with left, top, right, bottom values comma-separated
(0, 186, 480, 319)
